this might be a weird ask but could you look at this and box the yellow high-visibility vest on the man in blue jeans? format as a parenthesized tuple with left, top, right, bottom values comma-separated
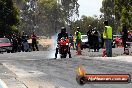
(103, 26, 112, 39)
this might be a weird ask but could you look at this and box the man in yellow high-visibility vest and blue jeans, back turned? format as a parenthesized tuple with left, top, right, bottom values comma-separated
(103, 21, 112, 57)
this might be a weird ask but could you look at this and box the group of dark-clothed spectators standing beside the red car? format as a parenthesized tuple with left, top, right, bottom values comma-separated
(5, 32, 39, 53)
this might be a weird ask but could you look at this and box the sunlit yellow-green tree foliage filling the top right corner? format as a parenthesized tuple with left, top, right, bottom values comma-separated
(114, 0, 132, 31)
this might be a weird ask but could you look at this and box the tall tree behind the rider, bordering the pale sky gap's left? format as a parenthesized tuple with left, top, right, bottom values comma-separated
(38, 0, 79, 35)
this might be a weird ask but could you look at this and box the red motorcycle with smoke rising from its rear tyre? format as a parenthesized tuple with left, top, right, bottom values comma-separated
(55, 37, 71, 58)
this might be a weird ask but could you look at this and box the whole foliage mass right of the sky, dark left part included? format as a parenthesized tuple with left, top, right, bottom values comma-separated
(100, 0, 132, 32)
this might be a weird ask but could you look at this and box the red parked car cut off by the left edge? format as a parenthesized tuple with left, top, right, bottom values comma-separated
(0, 38, 12, 53)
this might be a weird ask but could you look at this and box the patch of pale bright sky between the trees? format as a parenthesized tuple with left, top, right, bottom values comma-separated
(78, 0, 103, 18)
